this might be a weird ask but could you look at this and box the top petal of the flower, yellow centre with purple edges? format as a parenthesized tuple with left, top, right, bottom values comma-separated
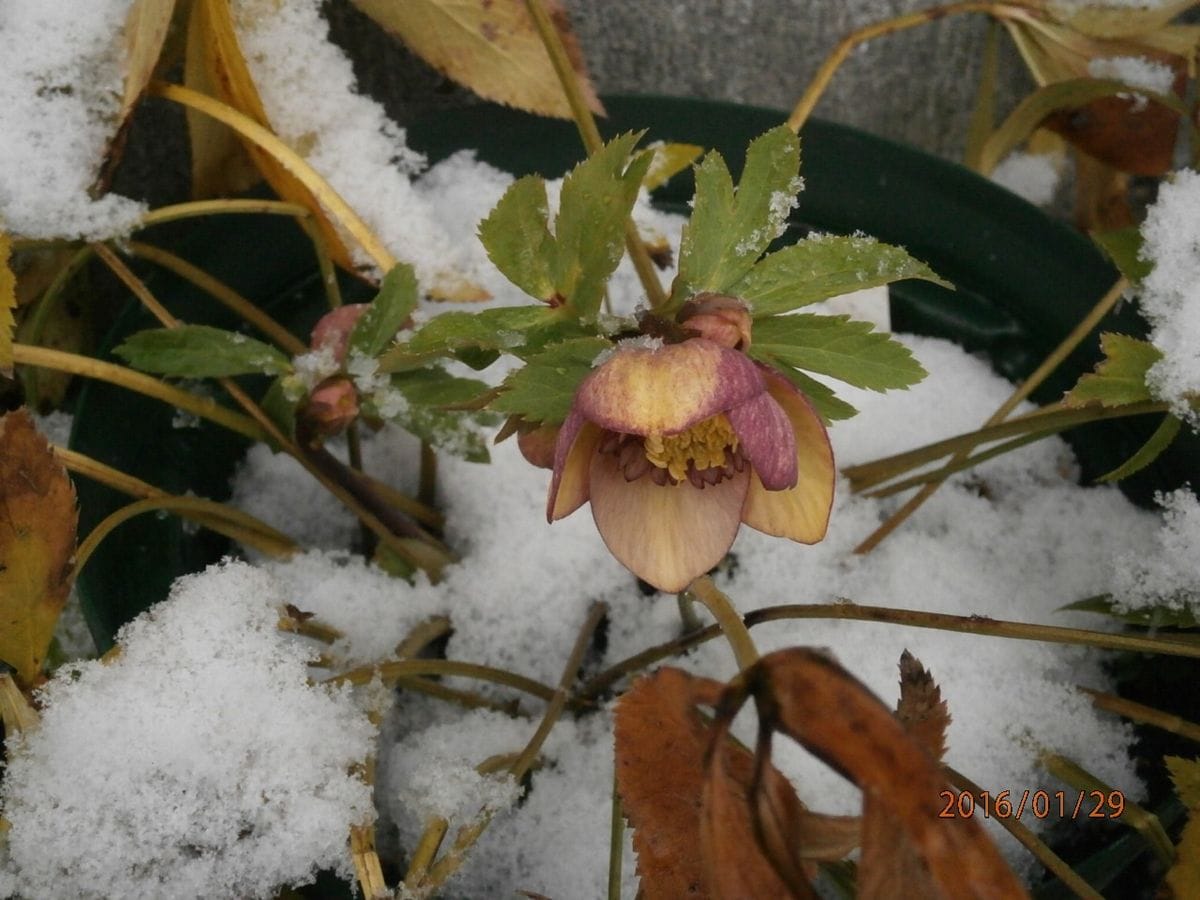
(575, 337, 763, 434)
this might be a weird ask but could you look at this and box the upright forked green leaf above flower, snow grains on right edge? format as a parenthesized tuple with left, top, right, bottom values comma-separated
(671, 125, 803, 305)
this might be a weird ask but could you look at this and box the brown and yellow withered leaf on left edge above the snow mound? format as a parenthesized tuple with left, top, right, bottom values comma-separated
(0, 409, 78, 685)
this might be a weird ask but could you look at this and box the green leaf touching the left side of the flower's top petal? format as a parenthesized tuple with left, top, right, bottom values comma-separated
(490, 337, 612, 425)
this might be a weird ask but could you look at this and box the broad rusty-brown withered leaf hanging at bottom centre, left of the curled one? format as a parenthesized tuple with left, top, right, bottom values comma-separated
(616, 668, 825, 900)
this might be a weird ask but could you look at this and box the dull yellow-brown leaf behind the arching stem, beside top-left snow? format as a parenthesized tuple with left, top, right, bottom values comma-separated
(184, 2, 262, 200)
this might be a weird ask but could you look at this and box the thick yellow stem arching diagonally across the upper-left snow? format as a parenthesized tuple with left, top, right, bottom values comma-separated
(148, 82, 396, 272)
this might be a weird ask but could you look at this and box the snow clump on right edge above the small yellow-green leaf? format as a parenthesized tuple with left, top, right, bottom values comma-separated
(1139, 169, 1200, 426)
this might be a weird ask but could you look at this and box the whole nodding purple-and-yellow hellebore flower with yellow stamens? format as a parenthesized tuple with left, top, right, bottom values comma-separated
(546, 337, 834, 592)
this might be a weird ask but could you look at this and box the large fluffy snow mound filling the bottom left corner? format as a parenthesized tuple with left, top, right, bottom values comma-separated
(0, 563, 376, 900)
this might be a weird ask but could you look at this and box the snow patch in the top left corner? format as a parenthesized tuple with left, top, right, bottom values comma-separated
(0, 0, 145, 240)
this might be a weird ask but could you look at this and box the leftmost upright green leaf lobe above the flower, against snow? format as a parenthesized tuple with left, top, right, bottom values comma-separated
(479, 175, 554, 302)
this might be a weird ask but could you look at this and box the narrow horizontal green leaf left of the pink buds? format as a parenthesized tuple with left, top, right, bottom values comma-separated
(113, 325, 292, 378)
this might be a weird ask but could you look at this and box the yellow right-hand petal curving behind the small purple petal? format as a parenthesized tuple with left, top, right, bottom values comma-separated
(742, 373, 835, 544)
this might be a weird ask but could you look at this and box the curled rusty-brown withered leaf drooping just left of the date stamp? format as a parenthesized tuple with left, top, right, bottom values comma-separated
(744, 648, 1027, 900)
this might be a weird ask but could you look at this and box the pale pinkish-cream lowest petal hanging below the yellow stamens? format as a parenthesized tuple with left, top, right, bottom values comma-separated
(590, 454, 750, 592)
